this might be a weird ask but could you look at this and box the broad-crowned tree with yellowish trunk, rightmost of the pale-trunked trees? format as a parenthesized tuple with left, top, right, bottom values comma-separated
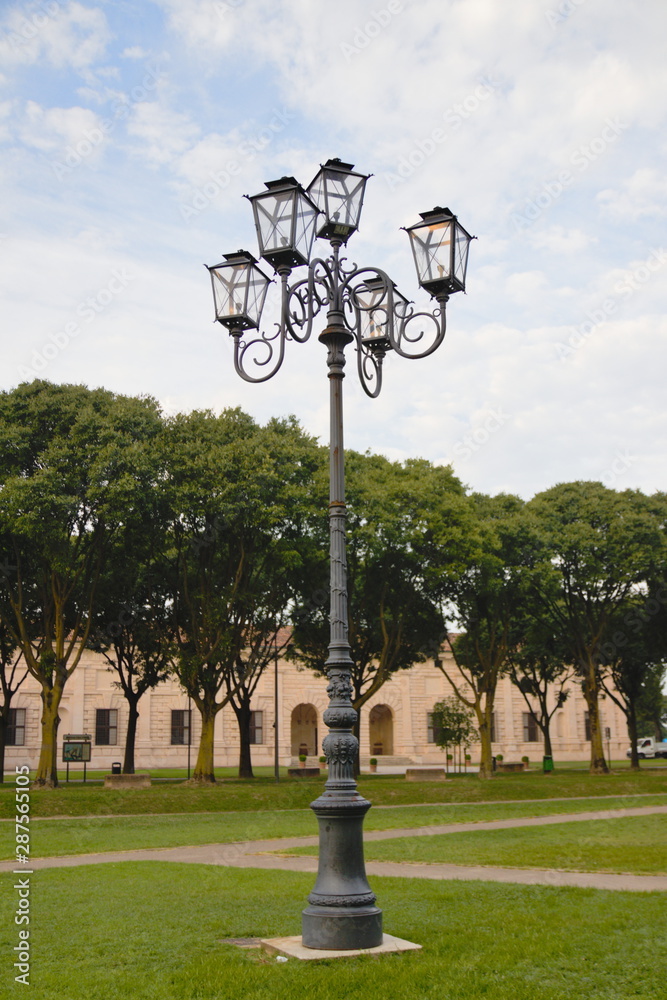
(528, 482, 664, 774)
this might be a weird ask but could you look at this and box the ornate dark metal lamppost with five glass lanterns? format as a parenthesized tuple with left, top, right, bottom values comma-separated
(208, 159, 474, 950)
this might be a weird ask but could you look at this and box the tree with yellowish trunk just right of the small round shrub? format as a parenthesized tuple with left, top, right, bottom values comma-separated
(436, 494, 536, 779)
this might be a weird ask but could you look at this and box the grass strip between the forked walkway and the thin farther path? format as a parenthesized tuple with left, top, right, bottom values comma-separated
(5, 794, 667, 859)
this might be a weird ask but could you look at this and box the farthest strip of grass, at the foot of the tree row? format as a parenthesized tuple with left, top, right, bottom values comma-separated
(5, 768, 667, 818)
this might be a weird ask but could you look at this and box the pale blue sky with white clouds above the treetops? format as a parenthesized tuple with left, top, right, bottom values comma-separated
(0, 0, 667, 499)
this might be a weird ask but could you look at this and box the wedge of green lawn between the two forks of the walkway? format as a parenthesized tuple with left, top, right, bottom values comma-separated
(289, 815, 667, 875)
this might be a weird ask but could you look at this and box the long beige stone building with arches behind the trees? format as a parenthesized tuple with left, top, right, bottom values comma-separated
(6, 652, 629, 770)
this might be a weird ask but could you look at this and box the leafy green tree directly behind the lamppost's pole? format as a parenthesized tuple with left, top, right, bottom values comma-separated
(291, 451, 464, 764)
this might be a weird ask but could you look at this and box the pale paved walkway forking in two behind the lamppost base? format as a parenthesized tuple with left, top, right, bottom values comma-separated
(0, 806, 667, 892)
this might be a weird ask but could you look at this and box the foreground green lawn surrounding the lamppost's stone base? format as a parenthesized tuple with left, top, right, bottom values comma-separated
(0, 862, 667, 1000)
